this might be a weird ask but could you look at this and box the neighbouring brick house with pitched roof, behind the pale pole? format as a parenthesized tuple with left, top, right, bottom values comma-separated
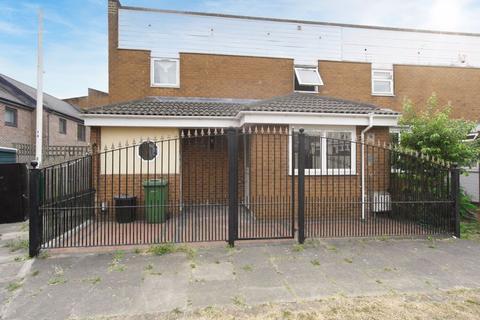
(0, 74, 90, 162)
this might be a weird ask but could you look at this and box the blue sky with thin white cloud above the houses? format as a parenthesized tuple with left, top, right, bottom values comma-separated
(0, 0, 480, 98)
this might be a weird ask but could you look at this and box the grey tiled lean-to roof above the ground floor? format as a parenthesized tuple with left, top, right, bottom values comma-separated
(86, 93, 398, 117)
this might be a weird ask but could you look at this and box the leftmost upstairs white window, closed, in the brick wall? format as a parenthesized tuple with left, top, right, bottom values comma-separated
(150, 58, 180, 88)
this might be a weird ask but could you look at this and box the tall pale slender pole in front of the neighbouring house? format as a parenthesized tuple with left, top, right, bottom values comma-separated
(35, 9, 43, 165)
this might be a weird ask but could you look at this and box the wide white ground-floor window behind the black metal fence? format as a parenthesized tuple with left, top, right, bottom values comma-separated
(289, 126, 356, 176)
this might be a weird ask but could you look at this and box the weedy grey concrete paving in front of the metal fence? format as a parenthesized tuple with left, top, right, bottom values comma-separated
(0, 239, 480, 319)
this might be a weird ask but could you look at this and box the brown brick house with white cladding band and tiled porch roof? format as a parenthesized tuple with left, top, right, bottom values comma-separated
(80, 0, 480, 225)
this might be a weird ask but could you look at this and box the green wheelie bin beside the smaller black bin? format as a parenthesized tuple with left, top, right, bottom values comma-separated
(143, 179, 168, 223)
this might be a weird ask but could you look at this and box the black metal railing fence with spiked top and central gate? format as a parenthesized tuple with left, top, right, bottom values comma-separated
(30, 126, 459, 254)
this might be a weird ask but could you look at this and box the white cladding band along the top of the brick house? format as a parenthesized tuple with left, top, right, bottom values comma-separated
(119, 8, 480, 67)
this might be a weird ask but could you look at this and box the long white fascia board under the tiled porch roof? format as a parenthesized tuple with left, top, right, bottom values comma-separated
(84, 111, 399, 128)
